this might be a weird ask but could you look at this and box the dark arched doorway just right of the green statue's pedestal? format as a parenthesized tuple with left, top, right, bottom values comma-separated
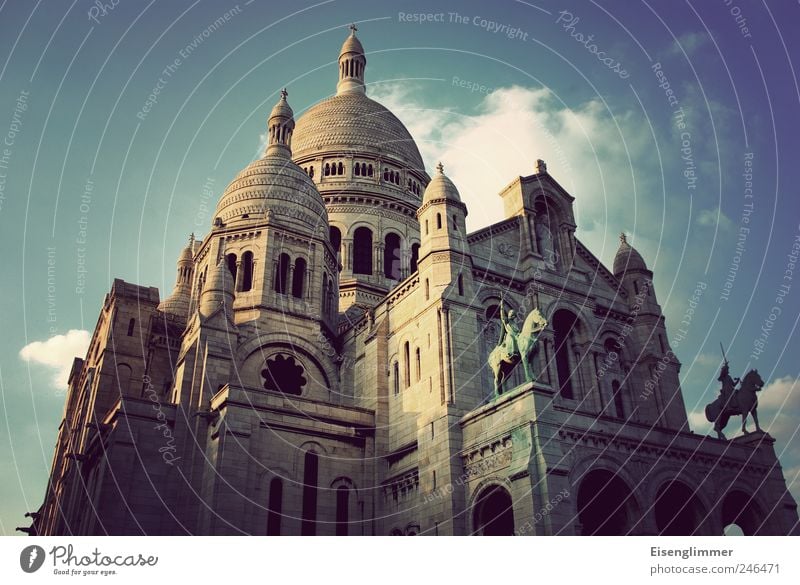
(578, 469, 636, 536)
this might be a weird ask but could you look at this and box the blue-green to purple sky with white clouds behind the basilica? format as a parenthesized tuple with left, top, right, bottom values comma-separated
(0, 0, 800, 534)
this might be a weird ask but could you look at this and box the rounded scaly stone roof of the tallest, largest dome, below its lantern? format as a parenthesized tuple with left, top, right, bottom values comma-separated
(292, 91, 424, 171)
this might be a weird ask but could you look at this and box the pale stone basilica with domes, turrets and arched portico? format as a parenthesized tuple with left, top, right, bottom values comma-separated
(25, 27, 798, 535)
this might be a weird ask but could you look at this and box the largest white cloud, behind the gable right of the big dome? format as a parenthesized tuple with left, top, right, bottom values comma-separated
(370, 84, 676, 260)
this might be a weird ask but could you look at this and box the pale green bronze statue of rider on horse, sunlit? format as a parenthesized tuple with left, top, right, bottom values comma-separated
(489, 303, 547, 395)
